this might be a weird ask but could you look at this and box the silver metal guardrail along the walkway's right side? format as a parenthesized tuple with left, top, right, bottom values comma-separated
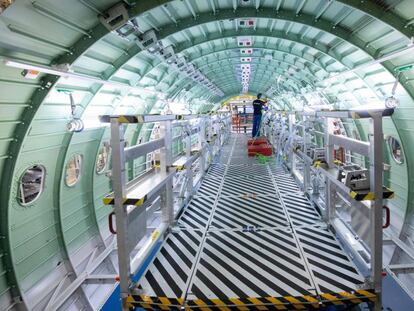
(266, 108, 394, 310)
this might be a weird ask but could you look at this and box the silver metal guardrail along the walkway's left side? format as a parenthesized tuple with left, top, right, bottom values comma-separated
(100, 113, 230, 310)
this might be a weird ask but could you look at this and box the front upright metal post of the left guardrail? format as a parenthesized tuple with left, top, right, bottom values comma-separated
(111, 118, 131, 310)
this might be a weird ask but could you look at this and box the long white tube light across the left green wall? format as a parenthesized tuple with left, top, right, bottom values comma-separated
(4, 58, 166, 97)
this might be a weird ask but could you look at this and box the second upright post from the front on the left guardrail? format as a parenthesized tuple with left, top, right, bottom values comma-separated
(160, 121, 174, 225)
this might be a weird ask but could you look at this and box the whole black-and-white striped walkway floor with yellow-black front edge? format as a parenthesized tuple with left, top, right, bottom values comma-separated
(131, 134, 375, 311)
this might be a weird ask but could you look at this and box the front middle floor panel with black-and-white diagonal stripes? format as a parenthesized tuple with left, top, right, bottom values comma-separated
(188, 230, 316, 301)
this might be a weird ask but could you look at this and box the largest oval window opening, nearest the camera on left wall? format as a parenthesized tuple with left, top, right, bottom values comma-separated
(18, 165, 46, 205)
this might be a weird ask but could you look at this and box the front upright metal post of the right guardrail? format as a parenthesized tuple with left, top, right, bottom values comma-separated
(369, 113, 384, 311)
